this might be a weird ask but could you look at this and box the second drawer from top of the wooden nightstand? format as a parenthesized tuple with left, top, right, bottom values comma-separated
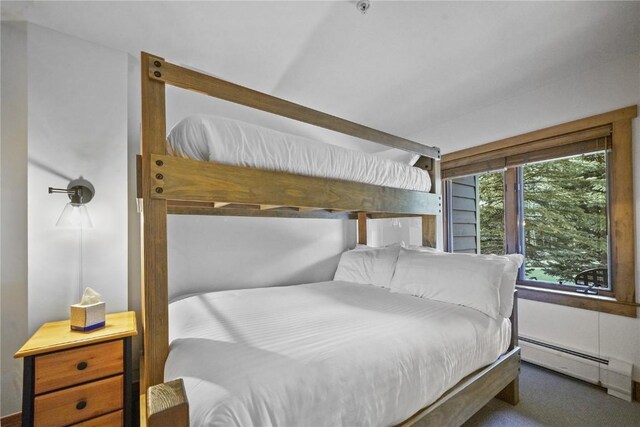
(34, 375, 123, 426)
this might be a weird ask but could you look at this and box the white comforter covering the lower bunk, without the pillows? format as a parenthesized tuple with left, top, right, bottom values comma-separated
(165, 281, 511, 426)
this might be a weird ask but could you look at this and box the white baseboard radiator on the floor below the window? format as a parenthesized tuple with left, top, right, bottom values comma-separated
(518, 336, 633, 402)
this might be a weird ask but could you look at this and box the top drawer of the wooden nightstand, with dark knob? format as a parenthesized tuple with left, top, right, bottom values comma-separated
(35, 340, 123, 394)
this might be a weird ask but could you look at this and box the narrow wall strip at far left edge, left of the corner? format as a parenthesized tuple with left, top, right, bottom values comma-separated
(0, 22, 28, 415)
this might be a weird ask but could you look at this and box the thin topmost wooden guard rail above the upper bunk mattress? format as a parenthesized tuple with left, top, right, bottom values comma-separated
(142, 56, 440, 159)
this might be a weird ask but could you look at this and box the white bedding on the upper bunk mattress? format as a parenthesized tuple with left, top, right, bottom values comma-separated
(167, 114, 431, 192)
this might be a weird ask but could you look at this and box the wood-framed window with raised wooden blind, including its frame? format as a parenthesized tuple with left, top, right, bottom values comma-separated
(442, 106, 638, 317)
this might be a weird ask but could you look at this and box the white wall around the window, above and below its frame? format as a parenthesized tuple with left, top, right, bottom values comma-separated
(415, 54, 640, 381)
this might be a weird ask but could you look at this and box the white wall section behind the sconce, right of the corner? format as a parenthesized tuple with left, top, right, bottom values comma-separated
(28, 25, 128, 333)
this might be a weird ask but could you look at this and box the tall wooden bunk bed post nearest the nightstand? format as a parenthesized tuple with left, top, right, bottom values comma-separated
(140, 52, 169, 390)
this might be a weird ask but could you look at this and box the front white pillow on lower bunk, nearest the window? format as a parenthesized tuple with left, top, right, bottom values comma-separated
(391, 250, 505, 319)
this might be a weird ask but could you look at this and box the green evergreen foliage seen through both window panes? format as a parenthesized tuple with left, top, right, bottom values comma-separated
(478, 153, 607, 284)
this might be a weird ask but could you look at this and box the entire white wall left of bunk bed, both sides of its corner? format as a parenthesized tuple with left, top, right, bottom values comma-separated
(1, 22, 128, 416)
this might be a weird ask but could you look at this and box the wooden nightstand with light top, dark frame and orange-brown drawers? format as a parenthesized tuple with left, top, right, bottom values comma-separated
(14, 311, 137, 427)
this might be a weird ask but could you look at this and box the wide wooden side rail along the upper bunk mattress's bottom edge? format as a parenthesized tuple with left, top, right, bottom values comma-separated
(149, 155, 442, 215)
